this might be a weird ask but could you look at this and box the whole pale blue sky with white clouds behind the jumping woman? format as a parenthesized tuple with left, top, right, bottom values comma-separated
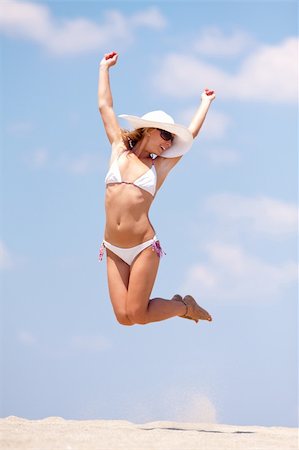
(0, 1, 298, 426)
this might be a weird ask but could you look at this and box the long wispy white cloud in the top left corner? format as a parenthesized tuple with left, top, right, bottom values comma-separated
(0, 0, 165, 55)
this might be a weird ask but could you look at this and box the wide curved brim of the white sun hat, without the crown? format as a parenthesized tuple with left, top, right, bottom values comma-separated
(118, 114, 193, 158)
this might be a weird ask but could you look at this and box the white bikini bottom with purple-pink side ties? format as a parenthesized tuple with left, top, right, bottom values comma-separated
(99, 235, 166, 266)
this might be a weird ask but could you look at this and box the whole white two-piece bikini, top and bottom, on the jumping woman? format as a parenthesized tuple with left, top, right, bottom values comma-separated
(99, 154, 165, 266)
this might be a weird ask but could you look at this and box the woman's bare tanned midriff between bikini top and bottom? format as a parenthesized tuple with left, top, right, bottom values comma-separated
(105, 183, 155, 248)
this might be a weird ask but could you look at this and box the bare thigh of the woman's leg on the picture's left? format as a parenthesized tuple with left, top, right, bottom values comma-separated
(106, 249, 134, 325)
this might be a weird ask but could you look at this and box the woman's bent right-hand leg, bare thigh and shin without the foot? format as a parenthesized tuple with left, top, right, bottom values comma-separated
(127, 247, 186, 324)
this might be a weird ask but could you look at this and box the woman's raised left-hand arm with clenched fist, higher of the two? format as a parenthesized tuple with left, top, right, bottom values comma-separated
(98, 52, 122, 144)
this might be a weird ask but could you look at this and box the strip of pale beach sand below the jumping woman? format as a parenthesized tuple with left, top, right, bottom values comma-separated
(0, 416, 298, 450)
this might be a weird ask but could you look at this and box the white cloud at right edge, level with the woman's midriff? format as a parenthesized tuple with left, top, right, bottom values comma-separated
(205, 194, 298, 236)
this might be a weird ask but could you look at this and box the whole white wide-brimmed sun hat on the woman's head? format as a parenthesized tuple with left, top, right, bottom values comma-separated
(118, 111, 193, 158)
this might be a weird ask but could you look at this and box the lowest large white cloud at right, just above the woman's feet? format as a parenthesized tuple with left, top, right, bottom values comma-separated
(183, 242, 298, 303)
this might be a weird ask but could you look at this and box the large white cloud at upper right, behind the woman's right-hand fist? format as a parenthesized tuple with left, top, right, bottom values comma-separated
(153, 38, 298, 103)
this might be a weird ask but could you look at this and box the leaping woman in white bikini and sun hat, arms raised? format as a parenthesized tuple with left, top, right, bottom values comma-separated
(98, 52, 215, 325)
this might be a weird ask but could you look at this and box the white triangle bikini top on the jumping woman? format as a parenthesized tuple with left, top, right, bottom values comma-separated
(105, 152, 157, 196)
